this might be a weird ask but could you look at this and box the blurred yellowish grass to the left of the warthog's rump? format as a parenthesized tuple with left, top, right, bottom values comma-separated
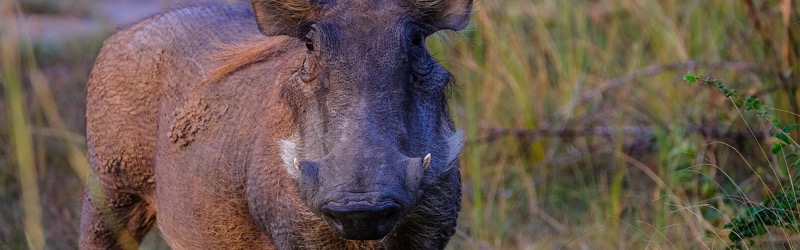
(0, 1, 97, 249)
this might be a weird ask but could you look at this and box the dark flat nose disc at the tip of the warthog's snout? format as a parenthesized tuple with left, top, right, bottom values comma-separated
(322, 203, 400, 240)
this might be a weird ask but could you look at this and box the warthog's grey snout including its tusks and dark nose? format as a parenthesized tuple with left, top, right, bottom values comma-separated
(296, 148, 430, 240)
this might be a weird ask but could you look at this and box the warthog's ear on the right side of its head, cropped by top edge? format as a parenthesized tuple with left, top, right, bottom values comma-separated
(411, 0, 472, 30)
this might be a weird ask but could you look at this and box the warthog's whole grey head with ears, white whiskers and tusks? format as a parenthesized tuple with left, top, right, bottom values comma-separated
(252, 0, 472, 240)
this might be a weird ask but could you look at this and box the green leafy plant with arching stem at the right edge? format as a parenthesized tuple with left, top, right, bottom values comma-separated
(683, 72, 800, 249)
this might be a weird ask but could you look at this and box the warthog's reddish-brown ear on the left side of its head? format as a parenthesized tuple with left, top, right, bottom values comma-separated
(250, 0, 326, 38)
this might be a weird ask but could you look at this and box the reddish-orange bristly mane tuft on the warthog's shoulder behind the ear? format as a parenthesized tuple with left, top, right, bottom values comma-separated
(198, 34, 296, 89)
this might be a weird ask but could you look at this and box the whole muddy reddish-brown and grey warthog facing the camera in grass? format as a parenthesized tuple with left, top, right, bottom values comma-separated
(80, 0, 472, 249)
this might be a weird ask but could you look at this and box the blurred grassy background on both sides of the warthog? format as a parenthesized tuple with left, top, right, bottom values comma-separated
(0, 0, 800, 249)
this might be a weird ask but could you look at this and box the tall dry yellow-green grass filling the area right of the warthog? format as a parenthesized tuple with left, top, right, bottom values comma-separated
(432, 0, 800, 249)
